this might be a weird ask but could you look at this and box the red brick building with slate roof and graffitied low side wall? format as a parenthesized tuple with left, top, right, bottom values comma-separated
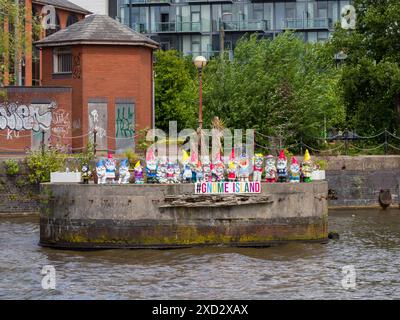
(0, 15, 158, 153)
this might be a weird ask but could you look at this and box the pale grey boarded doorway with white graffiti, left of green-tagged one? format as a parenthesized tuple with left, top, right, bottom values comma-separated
(89, 103, 108, 150)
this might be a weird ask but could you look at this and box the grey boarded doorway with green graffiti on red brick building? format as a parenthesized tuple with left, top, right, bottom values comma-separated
(115, 103, 135, 152)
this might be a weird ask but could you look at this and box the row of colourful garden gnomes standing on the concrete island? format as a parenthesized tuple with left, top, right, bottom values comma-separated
(87, 149, 313, 184)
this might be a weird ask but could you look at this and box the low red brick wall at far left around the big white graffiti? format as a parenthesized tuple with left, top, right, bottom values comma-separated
(0, 87, 72, 154)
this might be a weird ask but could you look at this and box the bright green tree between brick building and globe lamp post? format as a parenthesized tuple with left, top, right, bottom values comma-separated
(154, 50, 198, 132)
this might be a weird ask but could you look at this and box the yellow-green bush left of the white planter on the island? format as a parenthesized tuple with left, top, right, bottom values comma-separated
(26, 149, 68, 184)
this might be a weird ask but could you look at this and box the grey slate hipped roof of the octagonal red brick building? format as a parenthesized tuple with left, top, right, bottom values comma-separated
(35, 14, 159, 49)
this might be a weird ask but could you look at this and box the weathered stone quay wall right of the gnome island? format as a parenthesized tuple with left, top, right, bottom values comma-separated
(324, 156, 400, 207)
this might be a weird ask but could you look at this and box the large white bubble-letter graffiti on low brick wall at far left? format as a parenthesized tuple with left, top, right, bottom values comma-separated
(0, 102, 57, 132)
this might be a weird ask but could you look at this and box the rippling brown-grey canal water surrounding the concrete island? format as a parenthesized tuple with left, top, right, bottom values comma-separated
(0, 209, 400, 299)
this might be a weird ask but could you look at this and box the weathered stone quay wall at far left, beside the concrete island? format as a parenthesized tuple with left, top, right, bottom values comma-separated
(0, 160, 39, 217)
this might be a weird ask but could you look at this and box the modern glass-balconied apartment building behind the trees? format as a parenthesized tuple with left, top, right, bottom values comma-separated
(117, 0, 352, 57)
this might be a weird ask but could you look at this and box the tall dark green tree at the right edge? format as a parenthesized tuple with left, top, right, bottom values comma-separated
(330, 0, 400, 135)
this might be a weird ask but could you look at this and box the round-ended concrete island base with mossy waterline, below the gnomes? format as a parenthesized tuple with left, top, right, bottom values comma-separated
(40, 182, 328, 248)
